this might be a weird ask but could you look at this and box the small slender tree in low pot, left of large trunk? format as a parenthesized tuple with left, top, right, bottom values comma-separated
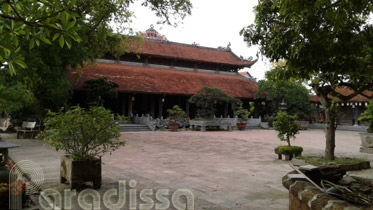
(273, 111, 303, 160)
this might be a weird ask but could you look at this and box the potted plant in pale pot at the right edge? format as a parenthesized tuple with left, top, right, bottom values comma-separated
(359, 101, 373, 153)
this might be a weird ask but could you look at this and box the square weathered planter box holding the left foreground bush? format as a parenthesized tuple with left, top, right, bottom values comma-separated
(60, 155, 101, 189)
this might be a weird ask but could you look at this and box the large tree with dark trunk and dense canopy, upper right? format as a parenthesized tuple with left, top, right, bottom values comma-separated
(241, 0, 373, 160)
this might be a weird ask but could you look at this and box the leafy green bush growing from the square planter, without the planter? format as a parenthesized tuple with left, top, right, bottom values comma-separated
(39, 107, 125, 160)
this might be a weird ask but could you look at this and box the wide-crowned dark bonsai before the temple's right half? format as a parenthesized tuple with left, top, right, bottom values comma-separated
(189, 86, 238, 118)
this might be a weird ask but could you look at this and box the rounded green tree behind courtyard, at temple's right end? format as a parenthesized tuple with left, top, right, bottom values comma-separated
(255, 68, 311, 119)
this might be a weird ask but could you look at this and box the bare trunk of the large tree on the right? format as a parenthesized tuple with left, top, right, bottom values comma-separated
(313, 86, 336, 160)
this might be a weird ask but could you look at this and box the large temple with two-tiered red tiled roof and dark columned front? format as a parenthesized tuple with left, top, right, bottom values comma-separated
(69, 27, 257, 118)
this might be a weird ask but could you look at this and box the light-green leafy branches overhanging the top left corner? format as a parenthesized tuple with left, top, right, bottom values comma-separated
(0, 0, 192, 74)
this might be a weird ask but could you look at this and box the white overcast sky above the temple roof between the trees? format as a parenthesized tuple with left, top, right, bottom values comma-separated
(126, 0, 270, 79)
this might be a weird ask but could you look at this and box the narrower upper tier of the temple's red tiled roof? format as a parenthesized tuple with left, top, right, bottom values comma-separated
(140, 39, 255, 67)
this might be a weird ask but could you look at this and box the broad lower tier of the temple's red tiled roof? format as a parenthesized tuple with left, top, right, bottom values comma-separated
(69, 63, 257, 98)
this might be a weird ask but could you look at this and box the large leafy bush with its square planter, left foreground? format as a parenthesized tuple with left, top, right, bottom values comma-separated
(39, 107, 125, 189)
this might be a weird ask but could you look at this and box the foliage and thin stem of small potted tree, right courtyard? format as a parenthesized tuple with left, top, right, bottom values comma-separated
(273, 111, 300, 147)
